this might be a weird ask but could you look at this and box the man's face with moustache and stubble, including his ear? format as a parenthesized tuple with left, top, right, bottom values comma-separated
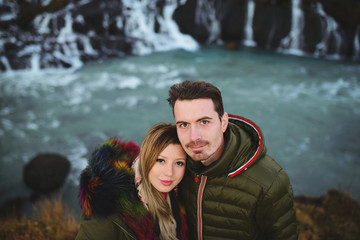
(174, 98, 228, 166)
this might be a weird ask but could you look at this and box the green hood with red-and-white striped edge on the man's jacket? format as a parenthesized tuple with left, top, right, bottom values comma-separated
(188, 115, 266, 177)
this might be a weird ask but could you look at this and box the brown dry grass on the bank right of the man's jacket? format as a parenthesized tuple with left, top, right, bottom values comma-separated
(295, 190, 360, 240)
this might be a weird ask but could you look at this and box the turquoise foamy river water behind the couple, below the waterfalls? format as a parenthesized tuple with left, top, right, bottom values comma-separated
(0, 49, 360, 212)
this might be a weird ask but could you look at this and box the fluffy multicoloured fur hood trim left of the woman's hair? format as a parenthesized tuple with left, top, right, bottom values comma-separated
(79, 138, 140, 217)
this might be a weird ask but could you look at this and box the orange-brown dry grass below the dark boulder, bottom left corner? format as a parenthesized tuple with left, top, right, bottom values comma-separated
(0, 197, 79, 240)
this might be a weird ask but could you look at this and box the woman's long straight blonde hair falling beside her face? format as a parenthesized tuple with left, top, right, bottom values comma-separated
(138, 123, 184, 240)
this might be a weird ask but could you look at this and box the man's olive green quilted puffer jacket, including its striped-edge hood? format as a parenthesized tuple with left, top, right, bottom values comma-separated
(180, 115, 298, 240)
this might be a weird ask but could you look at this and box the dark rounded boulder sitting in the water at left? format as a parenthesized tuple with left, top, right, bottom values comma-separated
(23, 153, 70, 194)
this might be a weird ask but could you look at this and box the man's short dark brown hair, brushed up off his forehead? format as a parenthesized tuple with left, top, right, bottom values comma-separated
(167, 80, 224, 120)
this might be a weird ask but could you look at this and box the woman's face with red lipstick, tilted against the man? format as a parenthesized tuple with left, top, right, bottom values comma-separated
(149, 144, 186, 192)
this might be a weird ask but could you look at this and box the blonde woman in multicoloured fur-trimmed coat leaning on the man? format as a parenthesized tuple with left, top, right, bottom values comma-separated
(76, 123, 187, 240)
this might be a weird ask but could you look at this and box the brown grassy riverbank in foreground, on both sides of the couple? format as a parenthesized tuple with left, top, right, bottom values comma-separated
(0, 190, 360, 240)
